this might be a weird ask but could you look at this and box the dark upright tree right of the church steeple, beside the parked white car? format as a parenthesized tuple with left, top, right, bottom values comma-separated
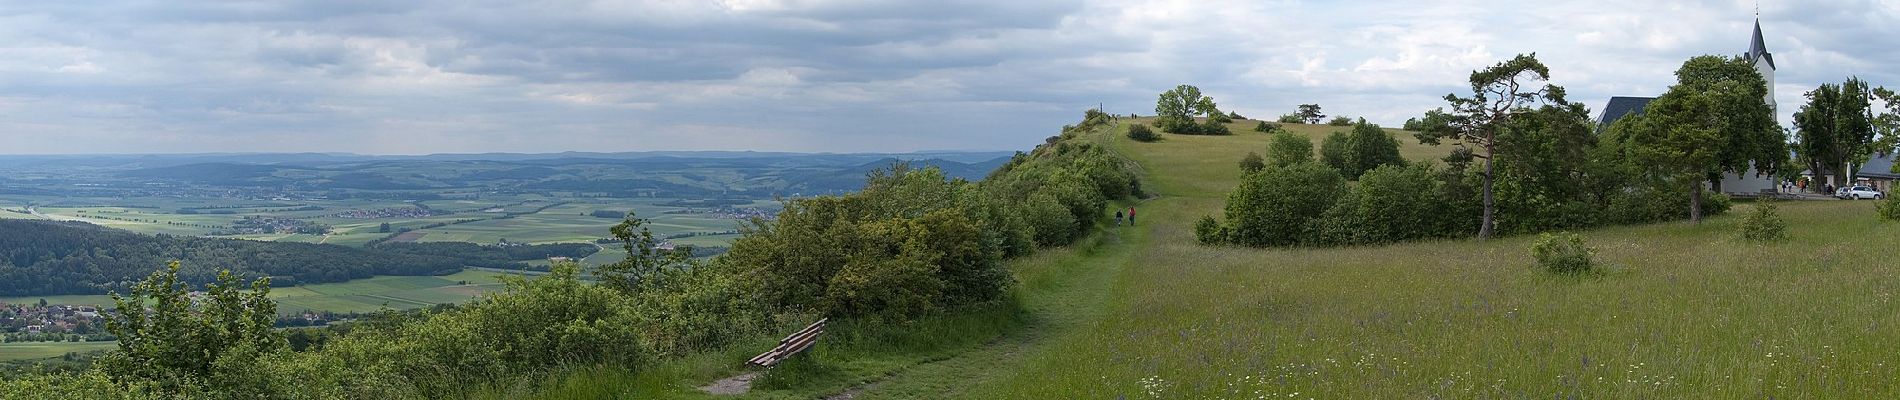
(1794, 78, 1875, 184)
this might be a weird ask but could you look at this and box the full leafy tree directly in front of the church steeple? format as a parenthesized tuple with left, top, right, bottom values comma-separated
(1630, 55, 1786, 222)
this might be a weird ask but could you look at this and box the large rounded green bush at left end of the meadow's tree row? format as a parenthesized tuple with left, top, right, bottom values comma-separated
(1226, 163, 1345, 246)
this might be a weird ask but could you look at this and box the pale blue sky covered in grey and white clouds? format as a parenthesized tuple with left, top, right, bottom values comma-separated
(0, 0, 1900, 154)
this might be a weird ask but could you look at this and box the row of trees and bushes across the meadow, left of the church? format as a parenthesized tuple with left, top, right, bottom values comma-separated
(1195, 55, 1788, 246)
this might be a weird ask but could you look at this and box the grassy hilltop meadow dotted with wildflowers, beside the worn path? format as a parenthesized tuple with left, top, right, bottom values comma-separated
(695, 123, 1900, 398)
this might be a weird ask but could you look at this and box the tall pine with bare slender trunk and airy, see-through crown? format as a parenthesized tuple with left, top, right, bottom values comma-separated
(1416, 53, 1569, 239)
